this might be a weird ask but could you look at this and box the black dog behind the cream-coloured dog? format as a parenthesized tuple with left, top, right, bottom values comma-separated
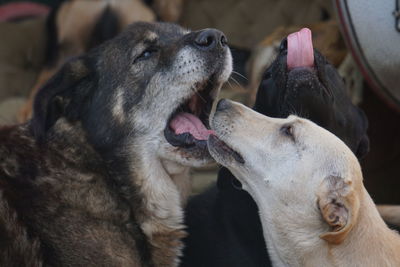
(181, 40, 369, 267)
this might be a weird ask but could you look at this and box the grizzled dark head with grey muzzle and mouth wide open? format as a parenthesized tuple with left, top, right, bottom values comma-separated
(31, 23, 232, 166)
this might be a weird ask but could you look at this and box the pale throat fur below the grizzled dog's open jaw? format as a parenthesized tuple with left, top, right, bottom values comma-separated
(128, 141, 190, 266)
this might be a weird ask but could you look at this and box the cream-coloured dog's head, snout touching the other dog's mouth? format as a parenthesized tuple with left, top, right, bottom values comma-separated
(208, 100, 362, 253)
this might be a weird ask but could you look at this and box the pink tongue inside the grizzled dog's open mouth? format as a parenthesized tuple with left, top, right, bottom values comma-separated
(170, 112, 214, 140)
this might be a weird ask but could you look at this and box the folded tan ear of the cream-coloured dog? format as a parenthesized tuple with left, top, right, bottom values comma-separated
(317, 176, 360, 244)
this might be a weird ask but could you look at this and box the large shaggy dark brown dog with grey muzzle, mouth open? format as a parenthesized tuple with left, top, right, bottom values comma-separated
(0, 23, 232, 266)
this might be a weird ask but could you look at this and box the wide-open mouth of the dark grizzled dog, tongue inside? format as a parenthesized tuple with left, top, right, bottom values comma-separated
(164, 82, 214, 148)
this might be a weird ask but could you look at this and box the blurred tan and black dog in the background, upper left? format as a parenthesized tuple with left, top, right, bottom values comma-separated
(18, 0, 155, 122)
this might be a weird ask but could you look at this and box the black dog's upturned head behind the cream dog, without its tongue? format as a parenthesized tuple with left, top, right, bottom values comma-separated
(254, 36, 369, 158)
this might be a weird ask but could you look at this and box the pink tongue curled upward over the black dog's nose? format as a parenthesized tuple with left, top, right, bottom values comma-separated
(287, 28, 314, 70)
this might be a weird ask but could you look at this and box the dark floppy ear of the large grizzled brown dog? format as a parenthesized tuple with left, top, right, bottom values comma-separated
(31, 57, 93, 142)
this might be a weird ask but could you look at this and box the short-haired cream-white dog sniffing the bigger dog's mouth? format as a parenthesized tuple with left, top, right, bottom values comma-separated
(208, 100, 400, 267)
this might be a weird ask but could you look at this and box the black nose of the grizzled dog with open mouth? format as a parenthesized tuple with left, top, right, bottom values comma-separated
(194, 29, 228, 50)
